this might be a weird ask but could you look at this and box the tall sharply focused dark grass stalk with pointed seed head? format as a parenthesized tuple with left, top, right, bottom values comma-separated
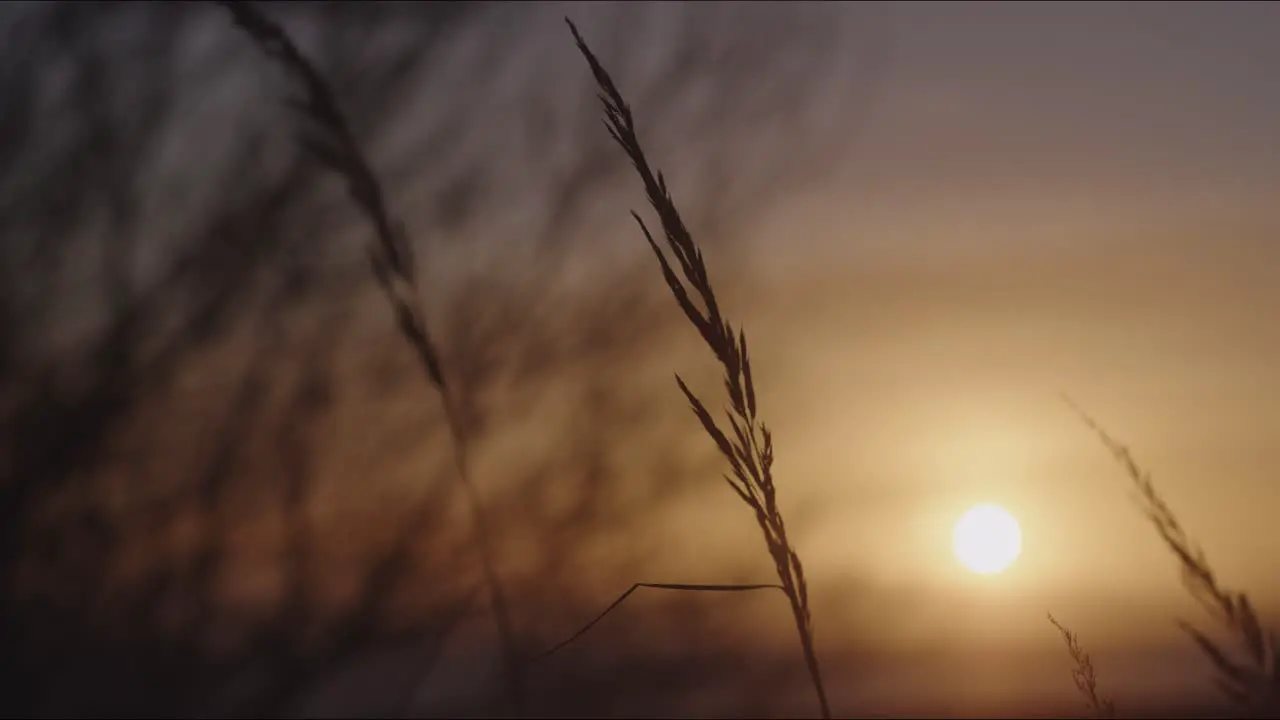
(564, 18, 831, 717)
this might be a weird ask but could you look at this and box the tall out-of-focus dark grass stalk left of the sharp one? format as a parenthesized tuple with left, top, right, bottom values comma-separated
(216, 0, 525, 716)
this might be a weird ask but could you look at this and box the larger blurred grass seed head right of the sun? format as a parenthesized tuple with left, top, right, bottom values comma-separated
(1065, 398, 1280, 714)
